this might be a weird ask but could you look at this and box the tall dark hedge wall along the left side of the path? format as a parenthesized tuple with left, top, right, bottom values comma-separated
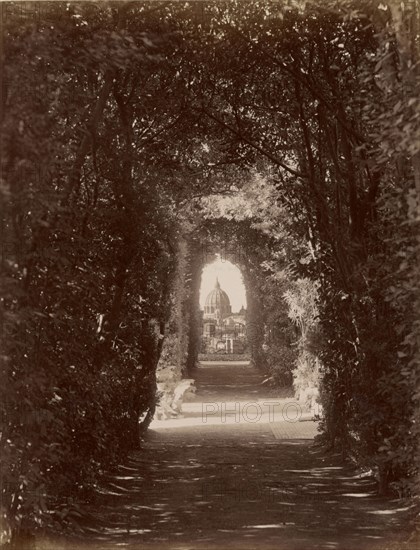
(1, 4, 184, 536)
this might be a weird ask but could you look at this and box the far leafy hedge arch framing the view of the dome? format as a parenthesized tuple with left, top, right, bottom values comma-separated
(182, 215, 296, 387)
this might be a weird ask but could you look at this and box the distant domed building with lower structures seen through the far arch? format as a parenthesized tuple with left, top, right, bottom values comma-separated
(202, 279, 246, 353)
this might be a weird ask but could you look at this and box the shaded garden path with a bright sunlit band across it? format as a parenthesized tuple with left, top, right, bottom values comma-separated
(37, 363, 415, 550)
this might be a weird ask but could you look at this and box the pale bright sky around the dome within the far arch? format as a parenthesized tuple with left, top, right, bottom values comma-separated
(200, 258, 246, 313)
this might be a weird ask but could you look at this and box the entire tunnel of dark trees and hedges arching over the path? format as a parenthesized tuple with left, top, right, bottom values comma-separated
(0, 0, 420, 541)
